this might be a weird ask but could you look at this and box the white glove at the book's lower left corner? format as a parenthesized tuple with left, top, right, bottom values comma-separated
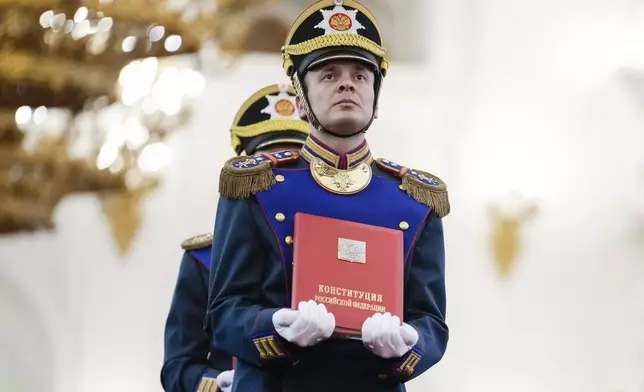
(273, 301, 335, 347)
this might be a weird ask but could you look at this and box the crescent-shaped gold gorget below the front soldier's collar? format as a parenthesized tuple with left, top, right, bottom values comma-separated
(311, 158, 371, 195)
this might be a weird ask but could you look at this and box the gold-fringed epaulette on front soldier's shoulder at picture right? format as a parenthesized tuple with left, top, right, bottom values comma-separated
(376, 158, 450, 218)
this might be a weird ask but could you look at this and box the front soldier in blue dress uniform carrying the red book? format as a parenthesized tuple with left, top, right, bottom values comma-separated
(207, 0, 450, 392)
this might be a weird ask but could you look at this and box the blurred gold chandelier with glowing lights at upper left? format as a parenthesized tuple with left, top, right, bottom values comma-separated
(0, 0, 268, 254)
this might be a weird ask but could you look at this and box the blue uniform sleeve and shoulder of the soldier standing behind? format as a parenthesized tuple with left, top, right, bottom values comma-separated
(161, 235, 232, 392)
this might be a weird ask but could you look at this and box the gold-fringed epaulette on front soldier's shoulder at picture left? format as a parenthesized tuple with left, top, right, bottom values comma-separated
(219, 151, 299, 199)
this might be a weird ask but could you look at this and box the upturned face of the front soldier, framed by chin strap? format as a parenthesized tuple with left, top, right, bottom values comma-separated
(298, 60, 375, 135)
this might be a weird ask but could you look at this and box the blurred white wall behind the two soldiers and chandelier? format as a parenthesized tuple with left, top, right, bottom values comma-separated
(0, 0, 644, 392)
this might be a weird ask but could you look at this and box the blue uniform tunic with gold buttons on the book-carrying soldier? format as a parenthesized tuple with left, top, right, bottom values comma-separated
(207, 137, 448, 392)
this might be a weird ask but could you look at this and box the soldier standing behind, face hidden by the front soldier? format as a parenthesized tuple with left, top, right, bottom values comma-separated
(161, 85, 309, 392)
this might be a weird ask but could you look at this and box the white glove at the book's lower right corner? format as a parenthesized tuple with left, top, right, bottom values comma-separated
(362, 313, 418, 358)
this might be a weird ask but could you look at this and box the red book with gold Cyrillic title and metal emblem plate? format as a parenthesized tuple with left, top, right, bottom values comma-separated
(292, 212, 404, 336)
